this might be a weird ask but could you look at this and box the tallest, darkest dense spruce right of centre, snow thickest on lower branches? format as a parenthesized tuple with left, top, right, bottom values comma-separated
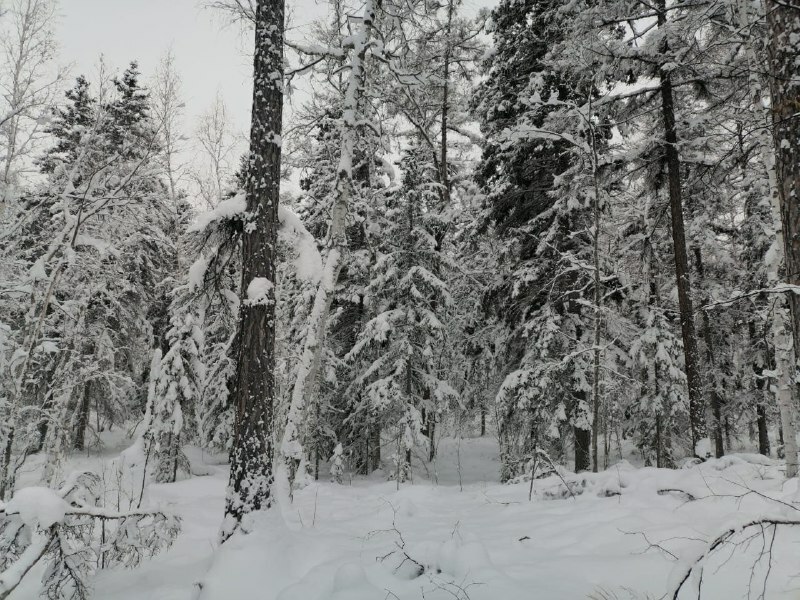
(476, 2, 592, 474)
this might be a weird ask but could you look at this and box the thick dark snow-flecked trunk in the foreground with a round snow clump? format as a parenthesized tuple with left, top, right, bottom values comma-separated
(223, 0, 284, 539)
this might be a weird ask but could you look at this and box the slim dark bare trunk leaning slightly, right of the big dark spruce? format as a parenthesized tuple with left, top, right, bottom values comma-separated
(657, 0, 705, 453)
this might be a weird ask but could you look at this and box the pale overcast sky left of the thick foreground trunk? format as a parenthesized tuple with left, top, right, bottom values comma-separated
(58, 0, 260, 135)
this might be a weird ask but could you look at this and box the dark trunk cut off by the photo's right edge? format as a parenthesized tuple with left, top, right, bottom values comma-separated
(766, 0, 800, 477)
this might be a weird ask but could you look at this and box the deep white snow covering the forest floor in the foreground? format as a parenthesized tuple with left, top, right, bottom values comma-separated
(12, 437, 800, 600)
